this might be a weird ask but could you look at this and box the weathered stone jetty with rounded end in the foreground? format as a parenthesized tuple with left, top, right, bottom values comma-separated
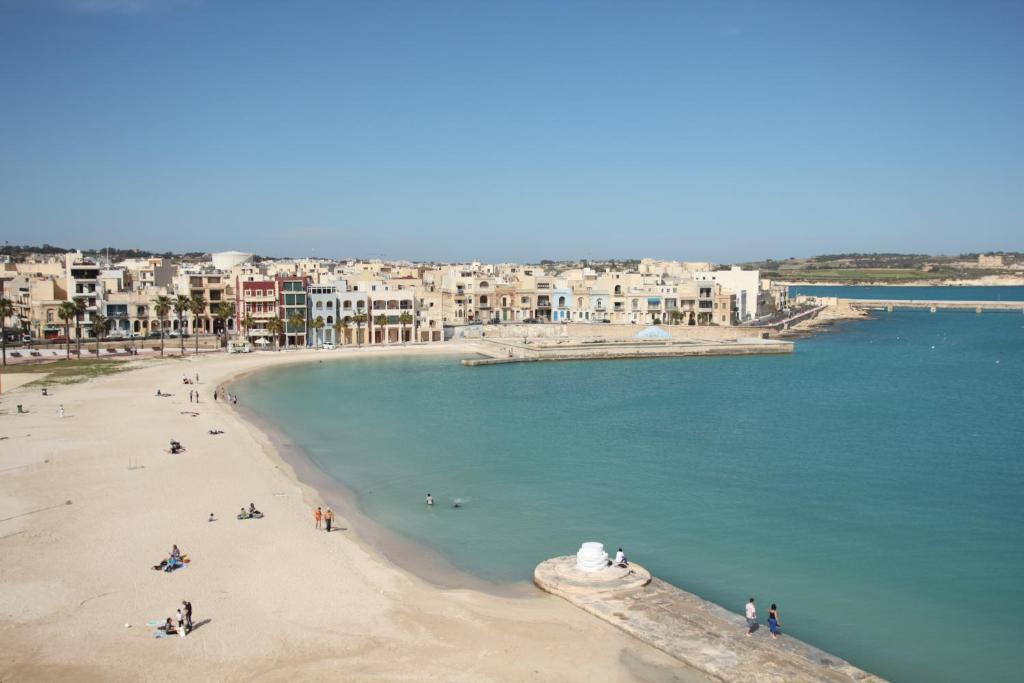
(534, 555, 884, 683)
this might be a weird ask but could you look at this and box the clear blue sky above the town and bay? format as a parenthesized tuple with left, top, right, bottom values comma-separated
(0, 0, 1024, 262)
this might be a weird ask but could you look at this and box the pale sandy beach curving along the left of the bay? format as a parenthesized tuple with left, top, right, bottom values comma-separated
(0, 345, 707, 681)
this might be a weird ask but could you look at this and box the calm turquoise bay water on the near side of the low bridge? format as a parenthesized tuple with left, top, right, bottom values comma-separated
(239, 307, 1024, 681)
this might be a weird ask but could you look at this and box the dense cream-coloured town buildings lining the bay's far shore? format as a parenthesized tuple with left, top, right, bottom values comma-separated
(0, 252, 787, 347)
